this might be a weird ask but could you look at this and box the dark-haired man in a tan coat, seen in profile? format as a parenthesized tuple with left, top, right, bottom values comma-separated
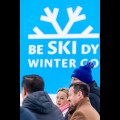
(68, 82, 100, 120)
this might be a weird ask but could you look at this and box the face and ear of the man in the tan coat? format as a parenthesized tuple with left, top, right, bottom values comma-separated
(68, 86, 80, 106)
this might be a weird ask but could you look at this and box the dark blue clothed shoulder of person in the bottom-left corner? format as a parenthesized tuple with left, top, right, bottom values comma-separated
(20, 107, 37, 120)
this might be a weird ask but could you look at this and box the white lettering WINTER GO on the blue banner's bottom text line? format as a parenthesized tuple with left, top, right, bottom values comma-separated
(28, 58, 99, 68)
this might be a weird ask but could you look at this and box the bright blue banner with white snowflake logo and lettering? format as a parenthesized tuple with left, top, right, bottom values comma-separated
(20, 0, 100, 94)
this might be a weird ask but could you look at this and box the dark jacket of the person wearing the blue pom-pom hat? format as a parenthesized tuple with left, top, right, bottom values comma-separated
(89, 81, 100, 114)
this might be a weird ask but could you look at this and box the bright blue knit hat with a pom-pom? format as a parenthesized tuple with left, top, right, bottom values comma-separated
(71, 62, 94, 84)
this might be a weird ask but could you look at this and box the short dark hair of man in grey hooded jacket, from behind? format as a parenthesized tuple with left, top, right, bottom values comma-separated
(22, 74, 44, 93)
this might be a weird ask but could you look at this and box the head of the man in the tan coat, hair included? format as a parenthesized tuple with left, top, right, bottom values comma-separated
(68, 82, 90, 106)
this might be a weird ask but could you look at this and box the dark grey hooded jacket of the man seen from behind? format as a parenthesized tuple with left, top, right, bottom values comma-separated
(22, 91, 64, 120)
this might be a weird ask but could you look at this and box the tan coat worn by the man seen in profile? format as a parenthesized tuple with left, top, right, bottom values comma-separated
(68, 97, 100, 120)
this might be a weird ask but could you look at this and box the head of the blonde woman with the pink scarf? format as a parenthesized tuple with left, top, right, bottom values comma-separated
(56, 88, 68, 107)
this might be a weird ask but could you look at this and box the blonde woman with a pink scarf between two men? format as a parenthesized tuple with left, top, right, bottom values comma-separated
(56, 88, 70, 117)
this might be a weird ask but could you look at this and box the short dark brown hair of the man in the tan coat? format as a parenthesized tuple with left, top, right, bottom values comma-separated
(69, 82, 90, 97)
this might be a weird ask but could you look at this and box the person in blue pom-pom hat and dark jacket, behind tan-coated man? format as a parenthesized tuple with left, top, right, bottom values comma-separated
(71, 62, 100, 114)
